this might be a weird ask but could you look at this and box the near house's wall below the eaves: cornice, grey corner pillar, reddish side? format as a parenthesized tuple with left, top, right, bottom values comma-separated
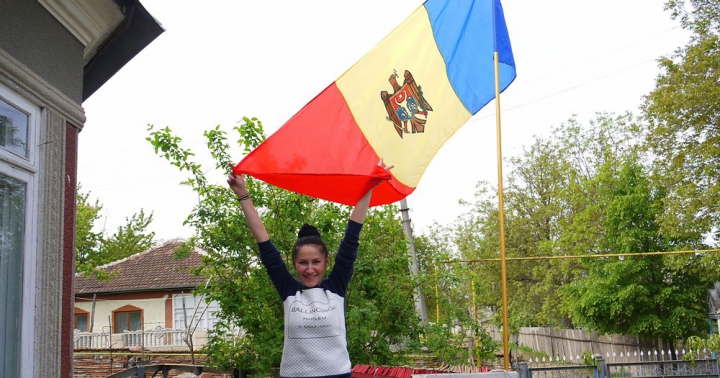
(0, 51, 85, 377)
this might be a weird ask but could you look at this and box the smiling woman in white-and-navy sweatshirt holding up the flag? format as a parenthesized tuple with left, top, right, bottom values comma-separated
(227, 160, 392, 378)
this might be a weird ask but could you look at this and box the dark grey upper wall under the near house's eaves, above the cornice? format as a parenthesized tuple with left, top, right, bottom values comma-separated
(0, 0, 84, 103)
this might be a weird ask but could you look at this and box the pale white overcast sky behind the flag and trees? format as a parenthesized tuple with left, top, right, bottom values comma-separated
(78, 0, 689, 241)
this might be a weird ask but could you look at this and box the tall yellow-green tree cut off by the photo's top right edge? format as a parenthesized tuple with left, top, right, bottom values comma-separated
(642, 0, 720, 238)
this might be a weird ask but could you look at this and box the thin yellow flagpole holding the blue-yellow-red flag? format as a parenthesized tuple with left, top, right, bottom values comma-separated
(493, 50, 510, 370)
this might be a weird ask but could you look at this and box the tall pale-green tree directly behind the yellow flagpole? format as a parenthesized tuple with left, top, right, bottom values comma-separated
(455, 114, 633, 329)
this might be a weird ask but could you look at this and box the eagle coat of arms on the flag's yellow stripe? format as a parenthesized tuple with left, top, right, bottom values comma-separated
(380, 70, 433, 138)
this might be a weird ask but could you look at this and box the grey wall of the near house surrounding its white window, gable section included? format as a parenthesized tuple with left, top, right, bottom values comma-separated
(0, 1, 85, 378)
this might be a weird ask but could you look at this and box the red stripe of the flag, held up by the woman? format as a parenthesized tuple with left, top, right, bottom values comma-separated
(233, 83, 414, 206)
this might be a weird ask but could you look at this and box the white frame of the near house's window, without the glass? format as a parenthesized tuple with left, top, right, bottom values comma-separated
(0, 83, 42, 378)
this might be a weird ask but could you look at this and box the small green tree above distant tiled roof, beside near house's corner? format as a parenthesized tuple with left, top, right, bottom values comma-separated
(75, 185, 155, 280)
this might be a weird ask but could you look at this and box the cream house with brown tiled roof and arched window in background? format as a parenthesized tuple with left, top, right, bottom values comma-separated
(73, 239, 219, 351)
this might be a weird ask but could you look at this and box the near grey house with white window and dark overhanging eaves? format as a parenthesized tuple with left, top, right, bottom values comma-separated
(0, 0, 163, 378)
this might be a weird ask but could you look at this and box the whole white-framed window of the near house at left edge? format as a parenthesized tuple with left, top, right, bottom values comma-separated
(0, 80, 40, 377)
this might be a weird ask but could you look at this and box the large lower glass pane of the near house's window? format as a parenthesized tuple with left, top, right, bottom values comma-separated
(0, 173, 26, 377)
